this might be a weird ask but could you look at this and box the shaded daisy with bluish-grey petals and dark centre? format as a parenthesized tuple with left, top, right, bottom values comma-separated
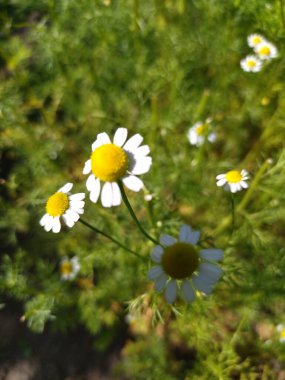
(148, 225, 223, 303)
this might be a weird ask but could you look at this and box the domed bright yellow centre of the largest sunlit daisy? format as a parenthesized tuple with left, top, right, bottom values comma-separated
(91, 144, 129, 182)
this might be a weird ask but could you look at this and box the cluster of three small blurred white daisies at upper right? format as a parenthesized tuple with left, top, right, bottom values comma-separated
(240, 34, 278, 73)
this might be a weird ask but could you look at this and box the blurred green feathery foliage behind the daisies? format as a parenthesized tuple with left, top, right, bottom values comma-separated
(0, 0, 285, 380)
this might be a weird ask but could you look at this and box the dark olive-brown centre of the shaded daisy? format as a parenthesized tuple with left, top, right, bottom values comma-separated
(161, 242, 199, 280)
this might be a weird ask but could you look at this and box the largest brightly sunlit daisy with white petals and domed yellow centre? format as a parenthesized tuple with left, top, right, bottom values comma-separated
(83, 128, 152, 207)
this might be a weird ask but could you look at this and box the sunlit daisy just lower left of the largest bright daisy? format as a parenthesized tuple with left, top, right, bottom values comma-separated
(40, 183, 85, 233)
